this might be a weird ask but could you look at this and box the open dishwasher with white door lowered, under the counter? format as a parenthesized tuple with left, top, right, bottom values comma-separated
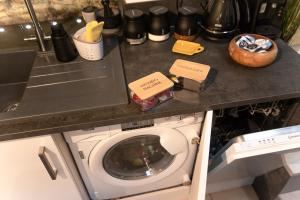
(207, 99, 300, 200)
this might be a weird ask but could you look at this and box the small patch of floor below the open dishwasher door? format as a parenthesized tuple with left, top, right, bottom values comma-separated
(205, 186, 258, 200)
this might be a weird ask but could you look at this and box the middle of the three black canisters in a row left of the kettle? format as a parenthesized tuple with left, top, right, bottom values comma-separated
(148, 6, 170, 41)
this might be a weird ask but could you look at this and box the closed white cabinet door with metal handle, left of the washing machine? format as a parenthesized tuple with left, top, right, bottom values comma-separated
(0, 136, 81, 200)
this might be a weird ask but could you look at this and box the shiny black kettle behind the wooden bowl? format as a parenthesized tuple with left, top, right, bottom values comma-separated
(201, 0, 251, 40)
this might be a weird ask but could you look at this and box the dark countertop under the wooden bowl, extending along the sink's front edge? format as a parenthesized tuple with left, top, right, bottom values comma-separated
(0, 35, 300, 140)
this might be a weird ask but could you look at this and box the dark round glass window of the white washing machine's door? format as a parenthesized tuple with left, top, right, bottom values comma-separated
(103, 135, 175, 180)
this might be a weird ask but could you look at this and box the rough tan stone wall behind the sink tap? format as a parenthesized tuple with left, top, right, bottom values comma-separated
(0, 0, 117, 26)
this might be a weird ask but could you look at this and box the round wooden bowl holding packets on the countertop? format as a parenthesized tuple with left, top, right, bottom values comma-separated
(228, 34, 278, 67)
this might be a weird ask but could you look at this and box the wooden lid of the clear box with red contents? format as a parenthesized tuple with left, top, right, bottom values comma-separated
(128, 72, 174, 100)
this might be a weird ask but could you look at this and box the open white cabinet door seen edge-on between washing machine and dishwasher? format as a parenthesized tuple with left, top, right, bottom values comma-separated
(190, 111, 213, 200)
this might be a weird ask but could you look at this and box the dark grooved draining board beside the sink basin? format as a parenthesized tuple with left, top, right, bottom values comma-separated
(15, 39, 128, 115)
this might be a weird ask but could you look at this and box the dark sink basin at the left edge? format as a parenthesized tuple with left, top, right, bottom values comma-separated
(0, 50, 36, 112)
